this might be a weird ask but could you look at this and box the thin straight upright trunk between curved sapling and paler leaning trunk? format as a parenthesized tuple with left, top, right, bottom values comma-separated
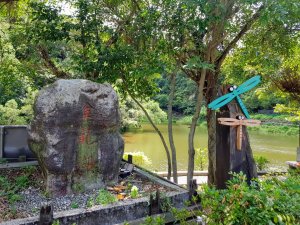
(168, 73, 178, 183)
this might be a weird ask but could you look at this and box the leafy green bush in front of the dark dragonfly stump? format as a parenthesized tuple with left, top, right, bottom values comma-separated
(201, 173, 300, 224)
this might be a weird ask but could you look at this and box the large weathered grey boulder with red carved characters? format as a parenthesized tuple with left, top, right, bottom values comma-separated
(28, 79, 124, 196)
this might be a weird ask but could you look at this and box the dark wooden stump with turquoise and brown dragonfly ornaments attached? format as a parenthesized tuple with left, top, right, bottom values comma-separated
(216, 87, 257, 189)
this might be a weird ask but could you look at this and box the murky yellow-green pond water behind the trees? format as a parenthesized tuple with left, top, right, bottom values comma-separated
(123, 124, 298, 171)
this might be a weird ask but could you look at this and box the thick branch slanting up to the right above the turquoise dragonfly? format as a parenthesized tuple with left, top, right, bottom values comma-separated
(215, 5, 264, 68)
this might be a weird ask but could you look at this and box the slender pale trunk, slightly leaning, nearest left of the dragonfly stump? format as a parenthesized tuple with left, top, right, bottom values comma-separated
(187, 69, 206, 188)
